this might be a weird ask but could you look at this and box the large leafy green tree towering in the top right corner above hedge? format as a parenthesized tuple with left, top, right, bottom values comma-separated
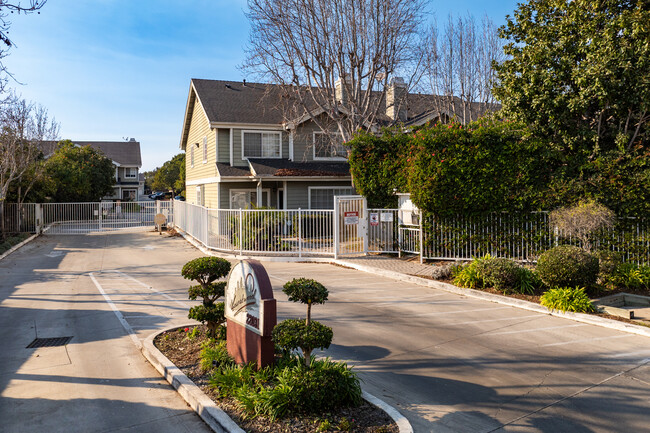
(494, 0, 650, 155)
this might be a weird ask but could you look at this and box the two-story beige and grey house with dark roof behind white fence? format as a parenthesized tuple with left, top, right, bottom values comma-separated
(180, 79, 480, 209)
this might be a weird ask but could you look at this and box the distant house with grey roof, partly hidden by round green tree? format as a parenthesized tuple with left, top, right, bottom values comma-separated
(41, 138, 144, 201)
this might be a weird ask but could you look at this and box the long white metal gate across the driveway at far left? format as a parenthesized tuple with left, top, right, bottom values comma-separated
(36, 200, 174, 235)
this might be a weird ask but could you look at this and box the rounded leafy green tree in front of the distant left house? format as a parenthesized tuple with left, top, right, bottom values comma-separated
(45, 140, 115, 203)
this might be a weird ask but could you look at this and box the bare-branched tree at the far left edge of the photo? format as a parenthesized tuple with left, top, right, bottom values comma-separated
(0, 94, 59, 237)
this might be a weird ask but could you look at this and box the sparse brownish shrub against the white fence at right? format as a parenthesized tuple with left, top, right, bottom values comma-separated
(549, 201, 616, 252)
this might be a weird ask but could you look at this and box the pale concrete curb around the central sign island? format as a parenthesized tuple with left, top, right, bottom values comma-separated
(141, 323, 413, 433)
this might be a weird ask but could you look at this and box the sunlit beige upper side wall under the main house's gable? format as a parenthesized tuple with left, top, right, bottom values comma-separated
(185, 101, 216, 181)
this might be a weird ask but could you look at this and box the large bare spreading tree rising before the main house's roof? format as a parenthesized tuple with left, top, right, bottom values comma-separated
(243, 0, 425, 141)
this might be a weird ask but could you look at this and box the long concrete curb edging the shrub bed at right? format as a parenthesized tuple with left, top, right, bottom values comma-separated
(332, 260, 650, 337)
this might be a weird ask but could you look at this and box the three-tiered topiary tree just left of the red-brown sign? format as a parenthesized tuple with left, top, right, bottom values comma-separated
(181, 257, 230, 338)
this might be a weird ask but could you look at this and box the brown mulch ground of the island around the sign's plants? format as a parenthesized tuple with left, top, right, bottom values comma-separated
(154, 325, 399, 433)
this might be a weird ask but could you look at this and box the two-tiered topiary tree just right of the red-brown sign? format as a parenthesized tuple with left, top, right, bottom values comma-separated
(273, 278, 334, 367)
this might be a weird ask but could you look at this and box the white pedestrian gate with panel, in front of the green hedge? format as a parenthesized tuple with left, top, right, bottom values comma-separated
(334, 195, 368, 258)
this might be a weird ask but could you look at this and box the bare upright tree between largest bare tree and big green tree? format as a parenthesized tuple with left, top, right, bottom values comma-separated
(424, 15, 504, 123)
